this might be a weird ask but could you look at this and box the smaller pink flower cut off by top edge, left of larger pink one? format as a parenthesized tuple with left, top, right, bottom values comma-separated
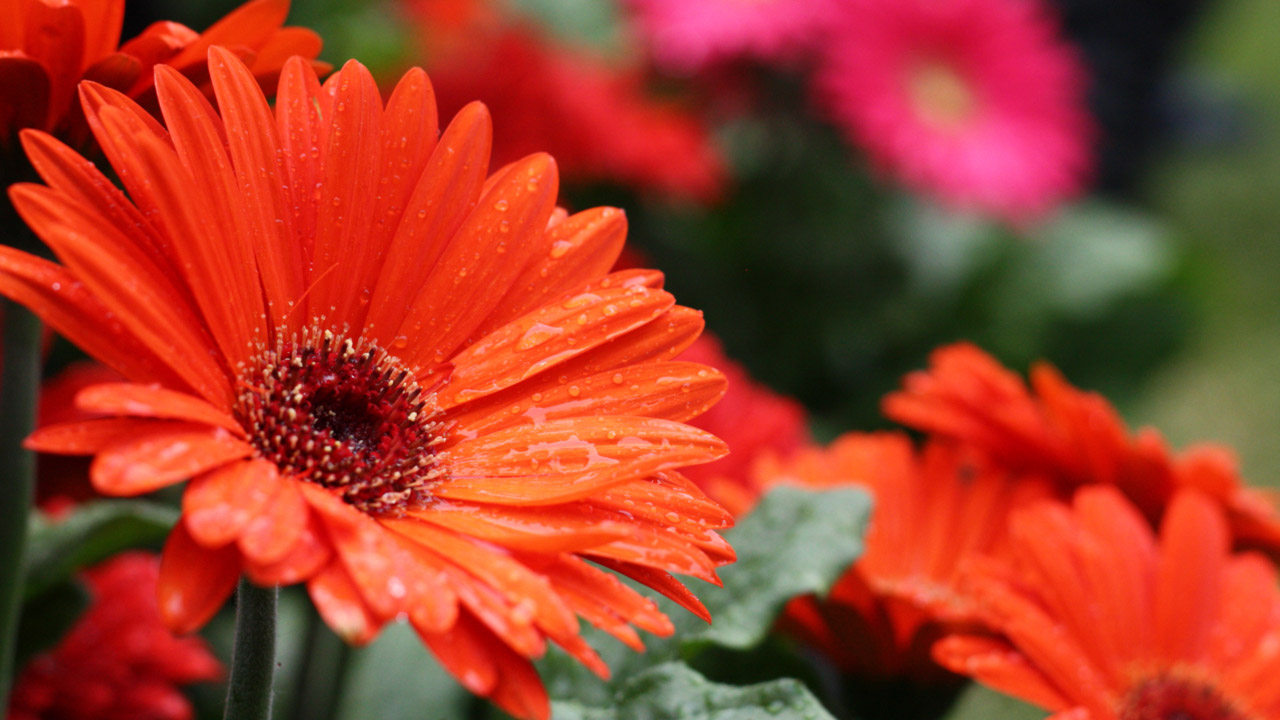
(628, 0, 835, 73)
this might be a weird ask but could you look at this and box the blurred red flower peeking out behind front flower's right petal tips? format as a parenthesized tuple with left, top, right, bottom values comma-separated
(680, 334, 812, 515)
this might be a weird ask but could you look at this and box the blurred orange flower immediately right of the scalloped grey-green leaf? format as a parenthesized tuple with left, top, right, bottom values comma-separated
(758, 433, 1047, 683)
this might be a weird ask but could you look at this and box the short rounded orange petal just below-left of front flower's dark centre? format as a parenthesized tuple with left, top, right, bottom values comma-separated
(182, 460, 276, 547)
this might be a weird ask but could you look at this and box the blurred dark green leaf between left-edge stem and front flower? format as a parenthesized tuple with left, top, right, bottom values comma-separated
(24, 500, 178, 600)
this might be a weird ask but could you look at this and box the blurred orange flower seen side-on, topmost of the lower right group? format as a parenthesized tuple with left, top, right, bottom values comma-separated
(883, 343, 1280, 551)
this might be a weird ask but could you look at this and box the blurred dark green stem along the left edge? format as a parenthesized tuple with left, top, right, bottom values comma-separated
(0, 300, 40, 707)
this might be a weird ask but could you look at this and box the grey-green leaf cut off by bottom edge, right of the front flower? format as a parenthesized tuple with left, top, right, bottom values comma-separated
(552, 662, 832, 720)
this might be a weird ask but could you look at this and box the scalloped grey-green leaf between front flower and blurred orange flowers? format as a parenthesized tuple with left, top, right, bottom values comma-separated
(682, 487, 872, 650)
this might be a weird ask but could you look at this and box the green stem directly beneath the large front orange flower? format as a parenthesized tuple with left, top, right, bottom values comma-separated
(223, 578, 279, 720)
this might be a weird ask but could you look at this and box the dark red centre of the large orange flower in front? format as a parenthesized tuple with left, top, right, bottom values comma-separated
(236, 331, 444, 515)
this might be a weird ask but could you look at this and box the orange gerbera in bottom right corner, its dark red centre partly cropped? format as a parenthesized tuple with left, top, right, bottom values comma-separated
(934, 487, 1280, 720)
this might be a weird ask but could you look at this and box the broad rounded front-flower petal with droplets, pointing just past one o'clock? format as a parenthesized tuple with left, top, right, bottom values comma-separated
(399, 155, 559, 366)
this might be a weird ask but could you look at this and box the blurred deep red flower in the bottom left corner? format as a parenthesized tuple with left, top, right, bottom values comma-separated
(9, 552, 223, 720)
